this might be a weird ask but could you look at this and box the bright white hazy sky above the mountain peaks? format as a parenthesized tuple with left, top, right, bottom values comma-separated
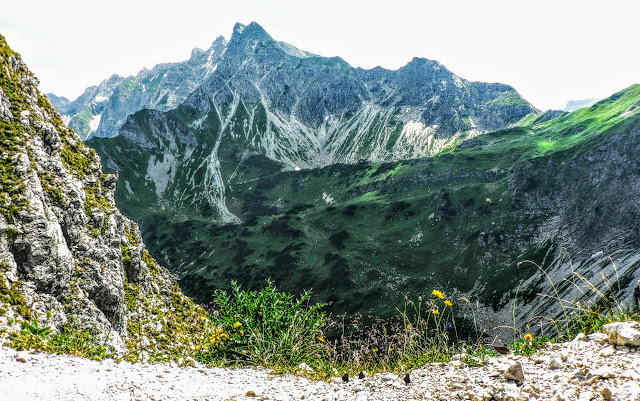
(0, 0, 640, 109)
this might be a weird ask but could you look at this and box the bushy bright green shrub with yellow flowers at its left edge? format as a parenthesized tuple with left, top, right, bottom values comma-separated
(201, 280, 327, 367)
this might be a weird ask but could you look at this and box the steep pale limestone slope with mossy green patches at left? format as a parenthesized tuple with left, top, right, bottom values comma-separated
(0, 36, 204, 356)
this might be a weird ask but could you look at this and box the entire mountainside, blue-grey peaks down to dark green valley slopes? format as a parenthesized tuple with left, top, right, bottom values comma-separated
(49, 23, 640, 334)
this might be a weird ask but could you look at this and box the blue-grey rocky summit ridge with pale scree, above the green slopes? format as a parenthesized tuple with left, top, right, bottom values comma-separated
(48, 22, 536, 148)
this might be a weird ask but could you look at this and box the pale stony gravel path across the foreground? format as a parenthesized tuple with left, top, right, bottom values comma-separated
(0, 330, 640, 401)
